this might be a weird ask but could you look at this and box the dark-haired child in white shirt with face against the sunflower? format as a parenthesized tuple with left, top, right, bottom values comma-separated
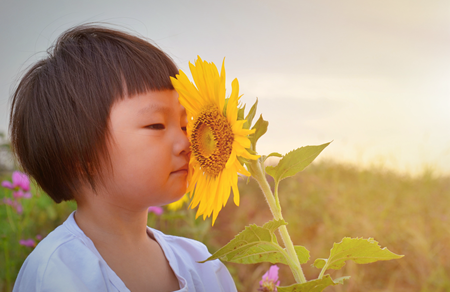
(10, 25, 236, 292)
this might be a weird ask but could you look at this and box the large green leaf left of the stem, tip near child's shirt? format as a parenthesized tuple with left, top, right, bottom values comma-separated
(201, 220, 287, 264)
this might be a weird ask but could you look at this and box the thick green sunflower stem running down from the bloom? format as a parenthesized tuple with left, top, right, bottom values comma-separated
(249, 160, 306, 284)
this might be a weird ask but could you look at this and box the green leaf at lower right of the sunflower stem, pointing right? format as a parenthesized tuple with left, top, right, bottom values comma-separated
(313, 237, 403, 270)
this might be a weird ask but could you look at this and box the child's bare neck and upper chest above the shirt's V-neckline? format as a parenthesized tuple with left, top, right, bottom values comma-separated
(75, 196, 180, 291)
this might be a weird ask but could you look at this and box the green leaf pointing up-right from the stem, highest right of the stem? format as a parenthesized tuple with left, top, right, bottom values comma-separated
(266, 142, 331, 182)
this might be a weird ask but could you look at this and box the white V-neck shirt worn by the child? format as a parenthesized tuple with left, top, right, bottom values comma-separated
(13, 213, 237, 292)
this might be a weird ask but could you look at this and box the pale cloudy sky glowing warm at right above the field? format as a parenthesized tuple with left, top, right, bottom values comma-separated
(0, 0, 450, 175)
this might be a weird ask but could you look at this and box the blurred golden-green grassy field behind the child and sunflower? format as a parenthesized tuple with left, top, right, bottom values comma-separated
(0, 162, 450, 292)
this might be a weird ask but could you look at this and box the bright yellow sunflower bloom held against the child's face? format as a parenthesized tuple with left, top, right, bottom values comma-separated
(171, 57, 259, 225)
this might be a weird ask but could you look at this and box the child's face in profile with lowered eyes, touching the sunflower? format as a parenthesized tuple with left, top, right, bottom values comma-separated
(101, 90, 190, 210)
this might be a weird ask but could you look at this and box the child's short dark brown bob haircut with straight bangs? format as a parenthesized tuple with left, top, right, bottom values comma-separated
(9, 24, 178, 203)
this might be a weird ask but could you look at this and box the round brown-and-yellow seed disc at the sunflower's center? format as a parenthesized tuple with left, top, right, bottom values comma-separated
(191, 105, 234, 177)
